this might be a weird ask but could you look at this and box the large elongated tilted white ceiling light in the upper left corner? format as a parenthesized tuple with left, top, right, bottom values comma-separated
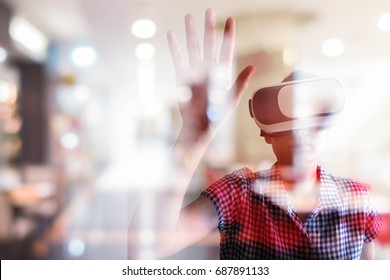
(9, 17, 49, 60)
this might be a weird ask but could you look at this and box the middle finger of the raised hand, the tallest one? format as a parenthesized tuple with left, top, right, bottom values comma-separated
(203, 9, 217, 62)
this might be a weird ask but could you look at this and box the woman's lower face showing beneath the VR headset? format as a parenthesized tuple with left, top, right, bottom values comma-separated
(266, 128, 326, 166)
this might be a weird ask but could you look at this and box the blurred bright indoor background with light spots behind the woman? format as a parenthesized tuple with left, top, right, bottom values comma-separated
(0, 0, 390, 259)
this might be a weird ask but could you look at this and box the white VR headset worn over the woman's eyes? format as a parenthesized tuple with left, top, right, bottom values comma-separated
(249, 78, 345, 136)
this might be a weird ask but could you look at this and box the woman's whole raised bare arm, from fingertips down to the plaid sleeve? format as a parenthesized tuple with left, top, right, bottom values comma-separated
(128, 10, 254, 259)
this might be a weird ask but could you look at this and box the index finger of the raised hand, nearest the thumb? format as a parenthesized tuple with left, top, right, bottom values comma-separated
(220, 17, 236, 67)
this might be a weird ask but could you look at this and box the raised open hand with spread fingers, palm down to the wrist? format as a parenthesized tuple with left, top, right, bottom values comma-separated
(168, 9, 254, 144)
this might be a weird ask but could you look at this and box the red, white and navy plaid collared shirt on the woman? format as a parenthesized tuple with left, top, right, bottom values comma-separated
(202, 164, 382, 259)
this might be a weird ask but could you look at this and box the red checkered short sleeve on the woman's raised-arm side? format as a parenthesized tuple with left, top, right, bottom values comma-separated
(202, 169, 252, 232)
